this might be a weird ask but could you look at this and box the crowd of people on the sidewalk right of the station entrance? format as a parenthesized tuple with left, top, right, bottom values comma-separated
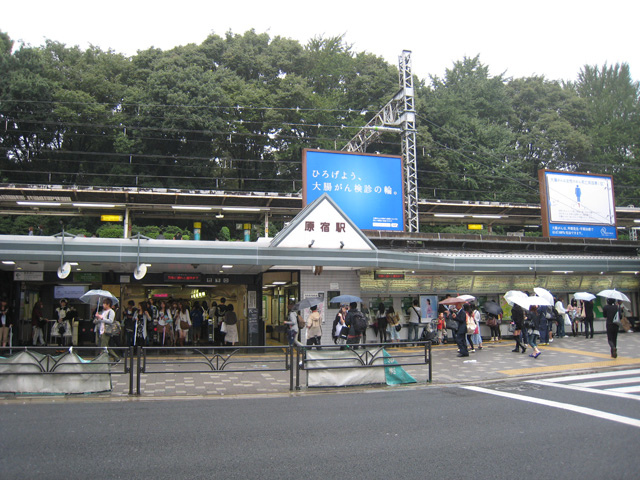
(285, 297, 630, 358)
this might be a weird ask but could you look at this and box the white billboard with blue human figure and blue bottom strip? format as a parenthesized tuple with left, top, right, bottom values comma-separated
(538, 170, 617, 239)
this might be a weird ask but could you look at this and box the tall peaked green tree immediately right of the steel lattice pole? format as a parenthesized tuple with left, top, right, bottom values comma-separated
(416, 56, 514, 200)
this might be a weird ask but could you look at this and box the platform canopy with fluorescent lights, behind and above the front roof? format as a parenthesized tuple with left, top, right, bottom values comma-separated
(0, 184, 640, 228)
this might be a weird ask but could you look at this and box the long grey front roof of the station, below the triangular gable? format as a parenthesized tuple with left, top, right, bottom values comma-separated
(0, 235, 640, 275)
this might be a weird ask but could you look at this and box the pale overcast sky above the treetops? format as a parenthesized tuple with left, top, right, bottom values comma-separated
(0, 0, 640, 80)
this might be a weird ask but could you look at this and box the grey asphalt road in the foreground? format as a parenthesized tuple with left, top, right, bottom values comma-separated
(0, 372, 640, 480)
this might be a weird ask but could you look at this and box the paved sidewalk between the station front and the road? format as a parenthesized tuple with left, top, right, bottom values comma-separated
(0, 333, 640, 402)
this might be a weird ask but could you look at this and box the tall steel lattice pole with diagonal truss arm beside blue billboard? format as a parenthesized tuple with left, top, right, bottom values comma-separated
(342, 50, 419, 232)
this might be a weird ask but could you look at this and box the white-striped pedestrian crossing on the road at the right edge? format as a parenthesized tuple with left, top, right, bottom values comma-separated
(526, 369, 640, 401)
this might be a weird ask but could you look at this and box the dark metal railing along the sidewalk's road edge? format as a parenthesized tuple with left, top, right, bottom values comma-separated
(0, 342, 432, 395)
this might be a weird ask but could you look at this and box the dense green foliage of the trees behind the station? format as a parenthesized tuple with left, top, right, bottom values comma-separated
(0, 31, 640, 205)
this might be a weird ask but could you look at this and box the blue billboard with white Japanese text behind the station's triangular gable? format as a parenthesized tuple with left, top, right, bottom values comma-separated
(302, 149, 404, 231)
